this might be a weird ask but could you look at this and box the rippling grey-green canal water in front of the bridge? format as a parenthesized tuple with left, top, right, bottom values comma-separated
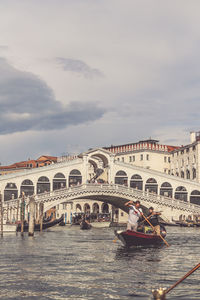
(0, 226, 200, 300)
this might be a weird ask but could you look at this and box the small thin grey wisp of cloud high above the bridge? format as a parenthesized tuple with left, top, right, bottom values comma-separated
(56, 57, 104, 79)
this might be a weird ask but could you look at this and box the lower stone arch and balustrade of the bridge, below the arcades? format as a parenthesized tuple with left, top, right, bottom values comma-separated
(4, 184, 200, 222)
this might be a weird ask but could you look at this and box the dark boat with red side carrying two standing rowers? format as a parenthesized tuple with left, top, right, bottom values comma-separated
(115, 226, 166, 247)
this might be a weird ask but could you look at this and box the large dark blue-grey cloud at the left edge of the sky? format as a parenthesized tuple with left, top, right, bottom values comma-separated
(0, 58, 105, 134)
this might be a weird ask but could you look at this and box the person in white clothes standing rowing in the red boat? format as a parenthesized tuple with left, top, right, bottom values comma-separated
(125, 200, 143, 231)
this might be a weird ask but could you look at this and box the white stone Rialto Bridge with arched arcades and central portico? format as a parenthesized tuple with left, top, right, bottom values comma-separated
(0, 149, 200, 221)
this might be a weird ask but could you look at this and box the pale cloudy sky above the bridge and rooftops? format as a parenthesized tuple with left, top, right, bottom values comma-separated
(0, 0, 200, 165)
